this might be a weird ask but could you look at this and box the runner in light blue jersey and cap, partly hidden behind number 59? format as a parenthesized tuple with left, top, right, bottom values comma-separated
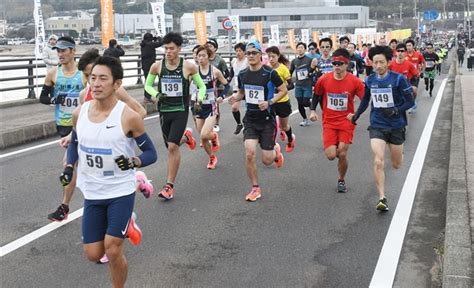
(40, 36, 87, 221)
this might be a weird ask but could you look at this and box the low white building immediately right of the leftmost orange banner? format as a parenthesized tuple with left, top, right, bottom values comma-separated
(114, 13, 173, 35)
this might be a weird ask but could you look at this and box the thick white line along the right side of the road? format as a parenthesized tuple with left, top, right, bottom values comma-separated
(369, 79, 447, 288)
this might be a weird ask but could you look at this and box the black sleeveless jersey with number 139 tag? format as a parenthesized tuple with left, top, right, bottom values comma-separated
(158, 58, 189, 112)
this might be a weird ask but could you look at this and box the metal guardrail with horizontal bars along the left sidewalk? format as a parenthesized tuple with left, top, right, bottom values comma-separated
(0, 52, 235, 99)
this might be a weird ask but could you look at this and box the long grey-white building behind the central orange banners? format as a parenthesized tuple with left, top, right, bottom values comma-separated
(181, 0, 369, 35)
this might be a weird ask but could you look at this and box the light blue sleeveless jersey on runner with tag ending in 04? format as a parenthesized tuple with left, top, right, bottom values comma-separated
(53, 66, 84, 126)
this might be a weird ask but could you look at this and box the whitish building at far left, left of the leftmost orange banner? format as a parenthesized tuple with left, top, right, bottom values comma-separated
(45, 10, 94, 35)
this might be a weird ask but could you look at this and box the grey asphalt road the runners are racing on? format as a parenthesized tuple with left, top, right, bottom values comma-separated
(0, 75, 449, 287)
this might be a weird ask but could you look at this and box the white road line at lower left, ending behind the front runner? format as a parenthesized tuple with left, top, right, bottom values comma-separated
(0, 208, 84, 257)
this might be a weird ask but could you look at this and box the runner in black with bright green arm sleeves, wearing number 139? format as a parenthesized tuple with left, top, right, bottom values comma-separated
(145, 32, 206, 200)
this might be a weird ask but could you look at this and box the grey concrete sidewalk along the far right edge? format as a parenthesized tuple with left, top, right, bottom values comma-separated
(443, 56, 474, 287)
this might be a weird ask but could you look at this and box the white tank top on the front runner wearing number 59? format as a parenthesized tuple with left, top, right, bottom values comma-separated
(76, 101, 135, 200)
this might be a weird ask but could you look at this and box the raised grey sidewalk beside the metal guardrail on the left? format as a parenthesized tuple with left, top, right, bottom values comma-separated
(0, 86, 156, 150)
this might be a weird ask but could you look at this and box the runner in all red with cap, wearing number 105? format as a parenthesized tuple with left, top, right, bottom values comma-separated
(310, 48, 365, 193)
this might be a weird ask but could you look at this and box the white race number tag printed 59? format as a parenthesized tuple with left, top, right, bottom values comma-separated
(79, 145, 115, 177)
